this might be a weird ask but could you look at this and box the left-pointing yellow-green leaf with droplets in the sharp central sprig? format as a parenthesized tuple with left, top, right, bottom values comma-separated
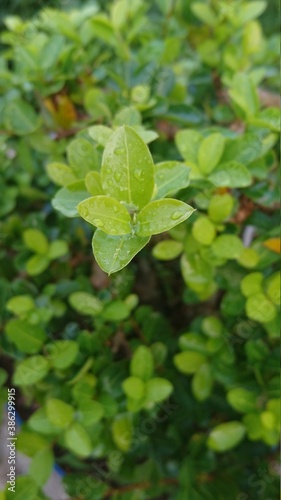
(77, 196, 132, 236)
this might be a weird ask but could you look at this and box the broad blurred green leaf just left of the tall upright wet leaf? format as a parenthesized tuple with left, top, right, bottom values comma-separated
(67, 139, 99, 179)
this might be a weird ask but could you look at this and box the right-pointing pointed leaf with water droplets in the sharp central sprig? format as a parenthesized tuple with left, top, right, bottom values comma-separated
(136, 198, 194, 236)
